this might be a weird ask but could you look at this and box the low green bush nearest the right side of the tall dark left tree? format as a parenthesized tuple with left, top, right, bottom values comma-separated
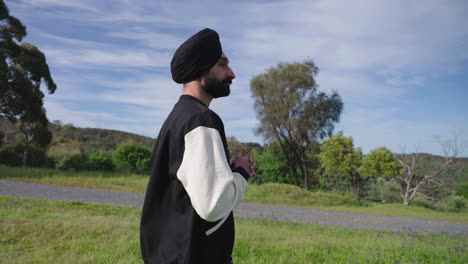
(47, 149, 88, 171)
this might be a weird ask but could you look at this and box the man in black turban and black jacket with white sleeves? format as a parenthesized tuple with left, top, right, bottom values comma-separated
(140, 29, 255, 264)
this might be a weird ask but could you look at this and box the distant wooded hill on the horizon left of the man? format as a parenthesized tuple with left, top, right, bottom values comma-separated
(0, 117, 156, 152)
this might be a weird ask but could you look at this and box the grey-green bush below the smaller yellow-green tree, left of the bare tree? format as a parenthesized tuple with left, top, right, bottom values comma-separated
(368, 177, 401, 203)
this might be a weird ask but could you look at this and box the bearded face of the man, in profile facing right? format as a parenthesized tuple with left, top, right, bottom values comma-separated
(201, 52, 236, 98)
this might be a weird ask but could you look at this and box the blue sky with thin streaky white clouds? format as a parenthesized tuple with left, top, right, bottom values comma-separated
(5, 0, 468, 157)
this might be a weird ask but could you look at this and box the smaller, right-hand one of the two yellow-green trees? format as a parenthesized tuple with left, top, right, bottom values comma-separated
(358, 147, 402, 178)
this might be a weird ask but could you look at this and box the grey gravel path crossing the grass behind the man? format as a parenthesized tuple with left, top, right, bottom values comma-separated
(0, 180, 468, 236)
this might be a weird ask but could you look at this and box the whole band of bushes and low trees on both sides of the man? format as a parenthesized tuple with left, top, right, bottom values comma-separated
(0, 117, 468, 211)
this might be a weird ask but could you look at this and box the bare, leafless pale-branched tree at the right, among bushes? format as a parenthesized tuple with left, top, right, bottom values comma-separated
(395, 132, 463, 205)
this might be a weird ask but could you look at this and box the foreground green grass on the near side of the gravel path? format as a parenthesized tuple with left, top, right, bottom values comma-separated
(0, 196, 468, 264)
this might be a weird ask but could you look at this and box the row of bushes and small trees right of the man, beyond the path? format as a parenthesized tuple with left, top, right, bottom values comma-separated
(239, 133, 468, 211)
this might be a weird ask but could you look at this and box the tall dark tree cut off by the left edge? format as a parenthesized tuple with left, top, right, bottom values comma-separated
(0, 0, 57, 166)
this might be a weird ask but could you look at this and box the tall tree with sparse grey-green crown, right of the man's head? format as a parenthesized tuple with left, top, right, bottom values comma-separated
(250, 60, 343, 189)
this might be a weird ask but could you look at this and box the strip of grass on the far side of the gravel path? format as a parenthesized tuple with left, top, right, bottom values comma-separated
(0, 166, 468, 223)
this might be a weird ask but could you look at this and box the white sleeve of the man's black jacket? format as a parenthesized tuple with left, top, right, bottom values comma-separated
(177, 126, 248, 222)
